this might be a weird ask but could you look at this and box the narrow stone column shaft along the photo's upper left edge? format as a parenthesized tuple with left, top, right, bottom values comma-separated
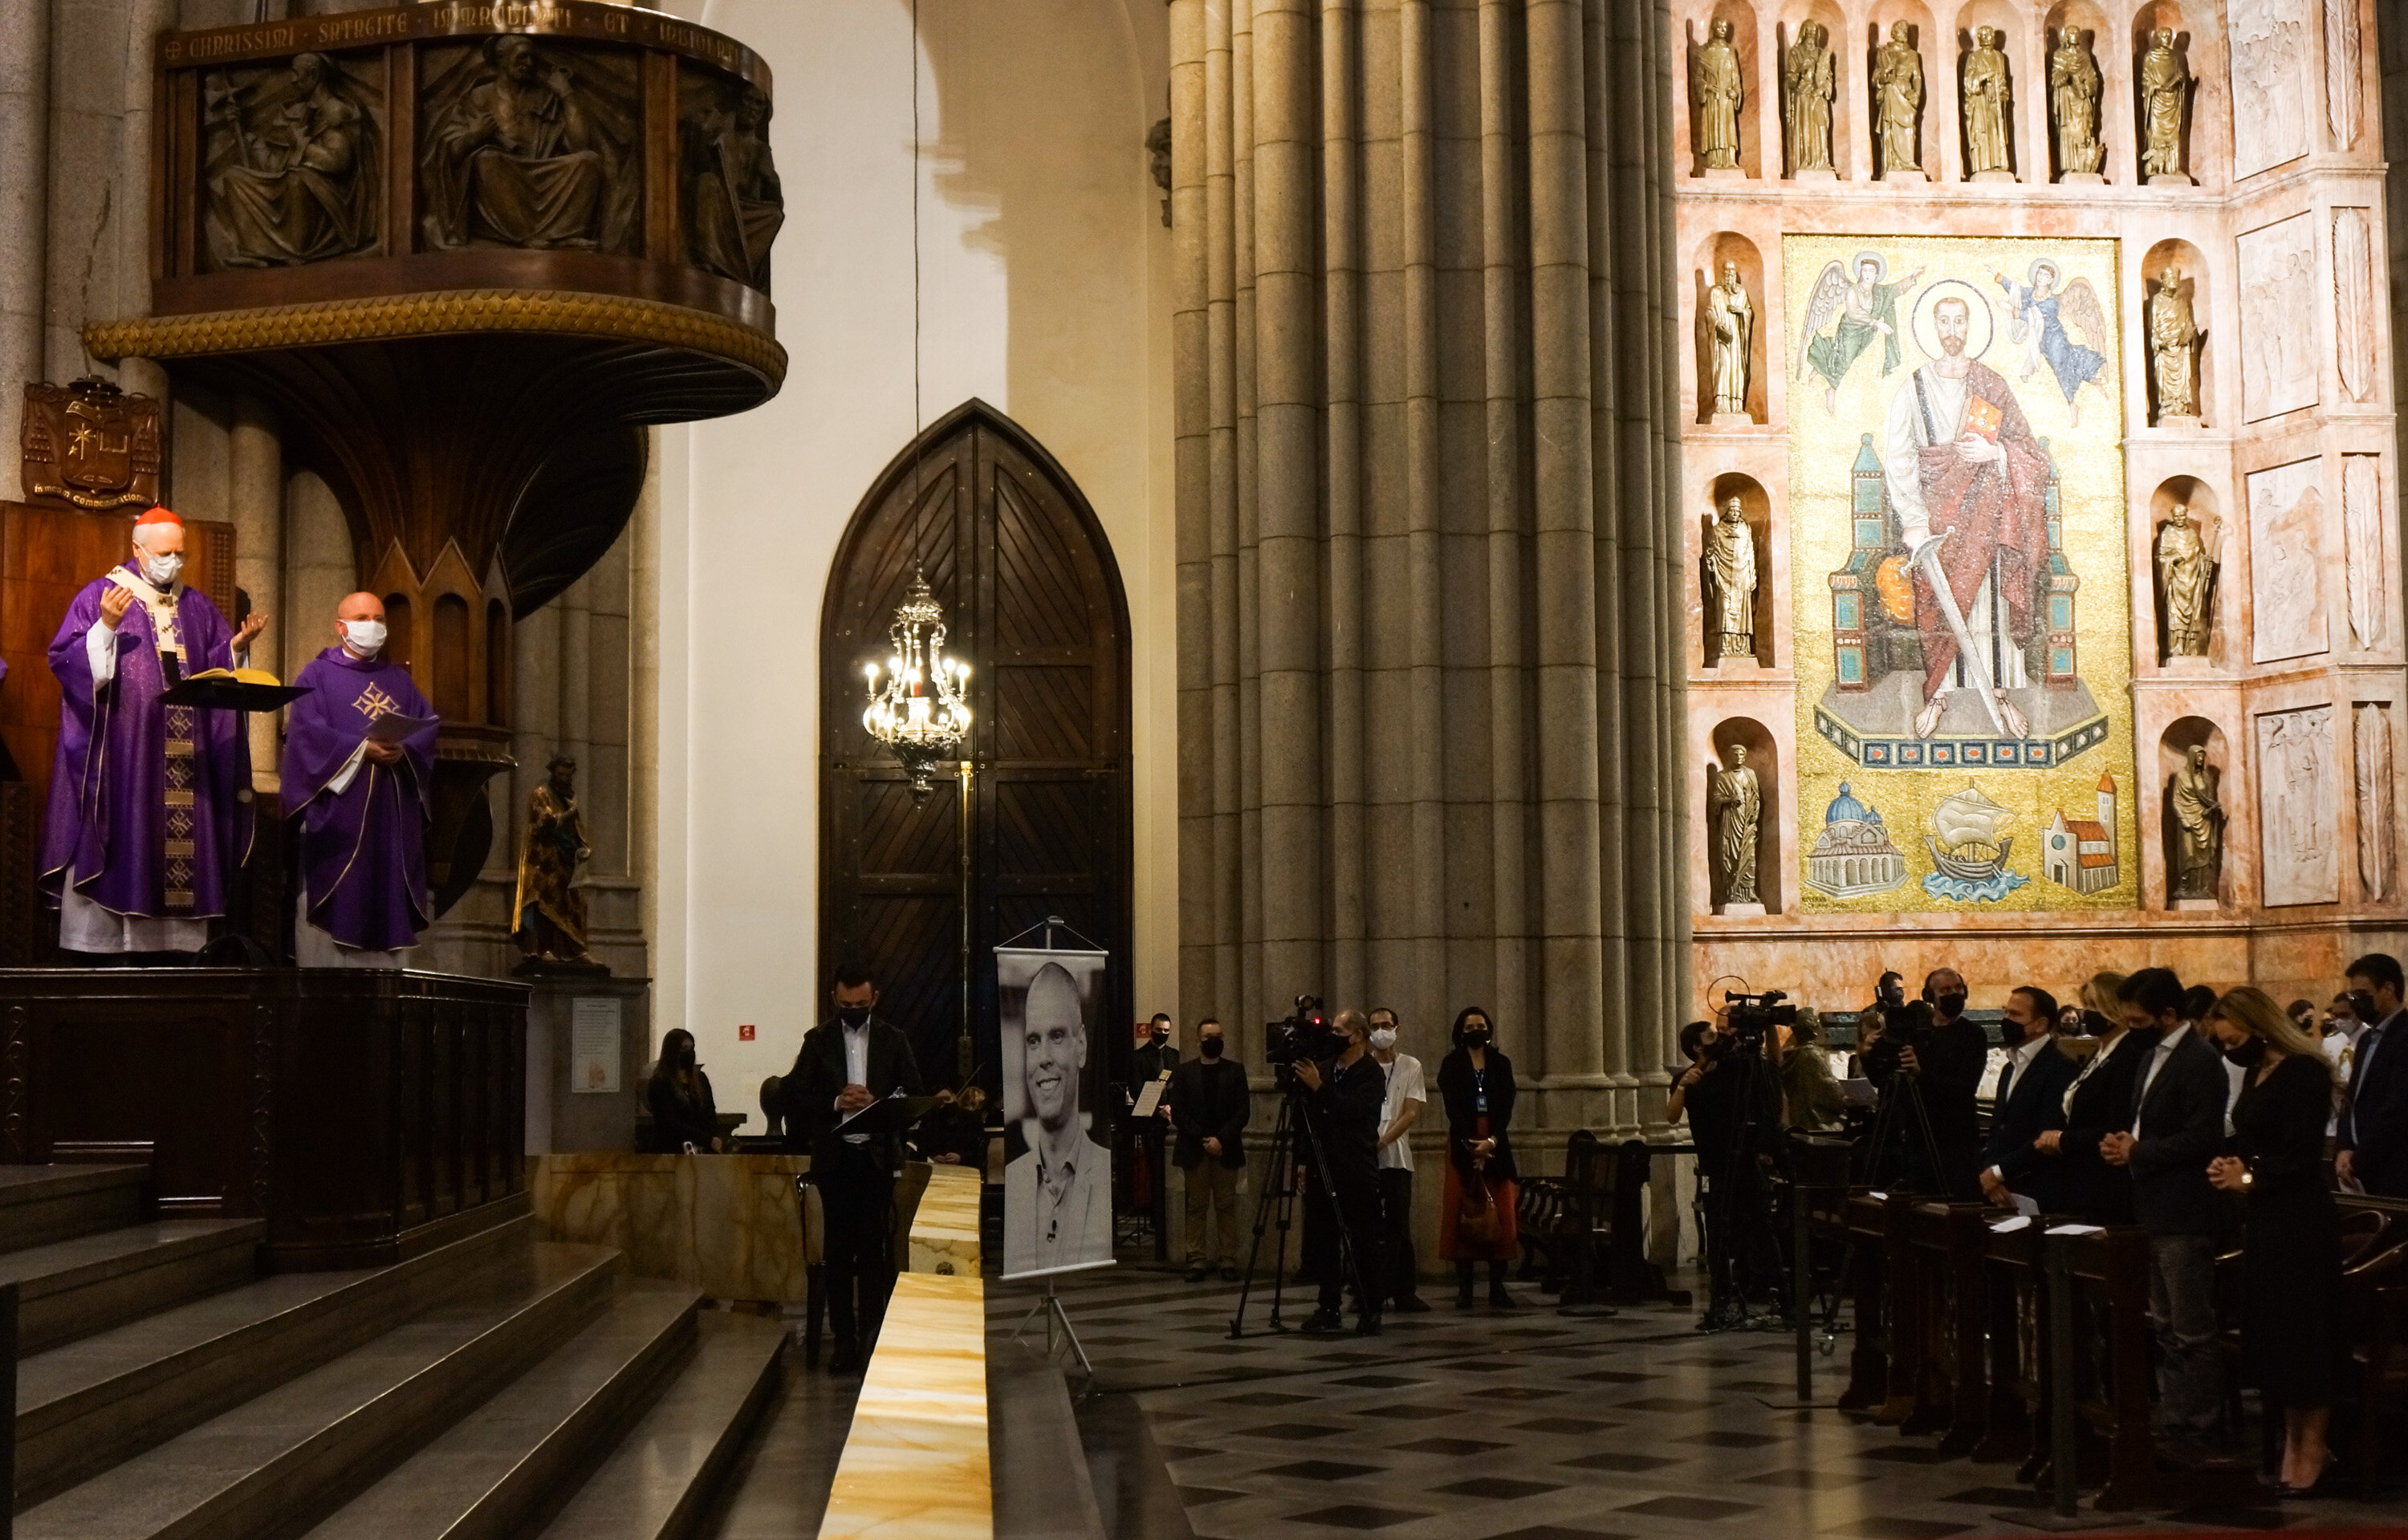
(0, 0, 51, 498)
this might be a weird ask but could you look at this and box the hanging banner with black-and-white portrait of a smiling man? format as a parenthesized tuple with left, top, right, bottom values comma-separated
(995, 945, 1112, 1278)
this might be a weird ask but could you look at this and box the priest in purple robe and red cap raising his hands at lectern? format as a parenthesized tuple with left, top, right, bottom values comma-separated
(41, 508, 267, 953)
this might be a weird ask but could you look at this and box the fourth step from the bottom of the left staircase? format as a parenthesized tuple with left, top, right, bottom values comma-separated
(17, 1220, 532, 1504)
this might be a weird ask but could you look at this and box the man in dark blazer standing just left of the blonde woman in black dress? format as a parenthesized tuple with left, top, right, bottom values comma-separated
(2100, 967, 2232, 1449)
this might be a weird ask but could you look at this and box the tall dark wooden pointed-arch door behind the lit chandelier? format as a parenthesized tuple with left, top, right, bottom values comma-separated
(814, 400, 1132, 1090)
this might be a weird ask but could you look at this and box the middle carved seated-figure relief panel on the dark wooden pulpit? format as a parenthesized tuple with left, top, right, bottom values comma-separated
(419, 34, 641, 250)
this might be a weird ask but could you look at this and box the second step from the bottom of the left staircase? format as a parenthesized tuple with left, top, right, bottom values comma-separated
(308, 1280, 701, 1540)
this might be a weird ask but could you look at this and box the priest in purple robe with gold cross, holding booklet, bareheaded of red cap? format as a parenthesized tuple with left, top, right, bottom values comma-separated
(284, 595, 436, 967)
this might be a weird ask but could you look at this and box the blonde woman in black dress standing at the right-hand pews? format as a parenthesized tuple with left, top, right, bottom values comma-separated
(2208, 984, 2348, 1497)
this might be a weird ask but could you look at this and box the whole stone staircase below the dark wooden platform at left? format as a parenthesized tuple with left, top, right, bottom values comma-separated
(0, 1167, 783, 1540)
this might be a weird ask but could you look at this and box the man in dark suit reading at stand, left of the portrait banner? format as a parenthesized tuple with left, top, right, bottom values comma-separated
(780, 962, 920, 1374)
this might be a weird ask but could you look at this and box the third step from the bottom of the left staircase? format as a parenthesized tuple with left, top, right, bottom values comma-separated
(14, 1244, 621, 1540)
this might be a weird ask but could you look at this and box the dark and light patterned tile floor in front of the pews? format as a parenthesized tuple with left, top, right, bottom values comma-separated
(990, 1266, 2408, 1540)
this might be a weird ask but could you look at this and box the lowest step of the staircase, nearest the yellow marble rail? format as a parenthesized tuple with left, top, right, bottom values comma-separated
(542, 1309, 785, 1540)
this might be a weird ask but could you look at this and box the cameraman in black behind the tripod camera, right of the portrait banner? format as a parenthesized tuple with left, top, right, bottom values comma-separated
(1296, 1010, 1387, 1335)
